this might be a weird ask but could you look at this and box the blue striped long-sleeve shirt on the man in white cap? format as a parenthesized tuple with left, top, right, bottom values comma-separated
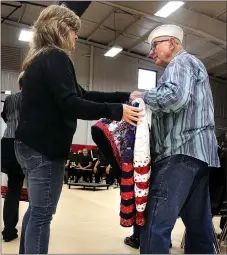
(142, 51, 220, 167)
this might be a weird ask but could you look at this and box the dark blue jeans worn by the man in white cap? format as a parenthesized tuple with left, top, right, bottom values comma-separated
(140, 155, 214, 254)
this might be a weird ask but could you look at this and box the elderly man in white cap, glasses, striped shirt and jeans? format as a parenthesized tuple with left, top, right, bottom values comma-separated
(131, 25, 220, 254)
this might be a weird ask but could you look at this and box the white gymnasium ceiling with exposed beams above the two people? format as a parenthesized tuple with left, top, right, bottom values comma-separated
(1, 1, 227, 79)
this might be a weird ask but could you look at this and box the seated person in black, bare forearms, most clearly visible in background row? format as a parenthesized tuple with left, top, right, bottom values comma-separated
(78, 148, 92, 182)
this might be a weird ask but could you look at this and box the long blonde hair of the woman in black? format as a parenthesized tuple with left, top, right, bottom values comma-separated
(22, 5, 81, 70)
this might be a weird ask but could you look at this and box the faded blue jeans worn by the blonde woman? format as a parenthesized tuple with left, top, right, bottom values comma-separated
(15, 140, 65, 254)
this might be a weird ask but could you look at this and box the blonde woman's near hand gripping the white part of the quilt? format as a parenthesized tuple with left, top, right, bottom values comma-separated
(122, 104, 144, 127)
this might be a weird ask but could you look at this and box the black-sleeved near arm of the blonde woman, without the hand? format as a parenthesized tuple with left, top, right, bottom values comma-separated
(45, 50, 123, 120)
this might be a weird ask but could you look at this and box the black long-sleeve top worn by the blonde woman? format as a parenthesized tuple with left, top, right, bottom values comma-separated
(16, 49, 129, 160)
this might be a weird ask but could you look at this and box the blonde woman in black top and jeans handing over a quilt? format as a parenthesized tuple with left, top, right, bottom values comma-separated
(15, 5, 142, 254)
